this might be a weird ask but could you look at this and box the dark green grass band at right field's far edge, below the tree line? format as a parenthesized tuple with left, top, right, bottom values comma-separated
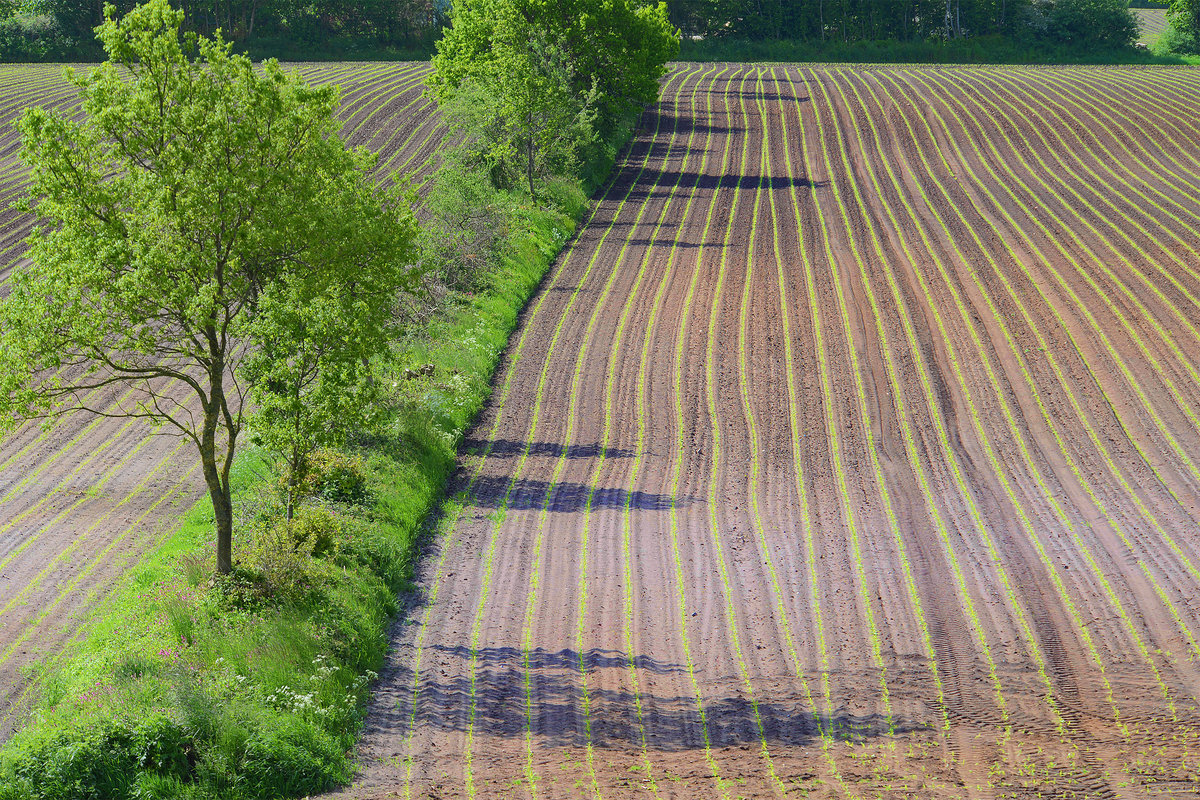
(679, 36, 1200, 64)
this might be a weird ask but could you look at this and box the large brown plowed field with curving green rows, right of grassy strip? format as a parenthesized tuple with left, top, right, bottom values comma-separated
(344, 65, 1200, 799)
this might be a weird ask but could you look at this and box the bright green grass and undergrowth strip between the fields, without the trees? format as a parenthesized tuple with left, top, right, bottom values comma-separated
(0, 130, 614, 800)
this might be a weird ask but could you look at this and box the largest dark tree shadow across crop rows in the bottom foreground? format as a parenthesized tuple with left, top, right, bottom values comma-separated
(384, 645, 920, 751)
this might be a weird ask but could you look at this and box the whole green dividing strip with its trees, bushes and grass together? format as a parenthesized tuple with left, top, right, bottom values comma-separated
(0, 0, 676, 800)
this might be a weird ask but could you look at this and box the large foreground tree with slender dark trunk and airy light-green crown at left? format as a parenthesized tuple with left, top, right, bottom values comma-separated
(0, 0, 415, 572)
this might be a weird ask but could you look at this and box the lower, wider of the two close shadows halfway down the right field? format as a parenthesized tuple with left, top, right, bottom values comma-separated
(470, 475, 691, 513)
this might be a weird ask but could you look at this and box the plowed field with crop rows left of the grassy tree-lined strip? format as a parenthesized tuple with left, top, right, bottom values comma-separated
(0, 64, 444, 740)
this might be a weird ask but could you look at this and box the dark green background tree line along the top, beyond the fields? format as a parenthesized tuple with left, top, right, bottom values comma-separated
(0, 0, 1180, 60)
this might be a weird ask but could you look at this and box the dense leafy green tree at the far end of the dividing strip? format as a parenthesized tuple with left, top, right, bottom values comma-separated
(430, 0, 679, 193)
